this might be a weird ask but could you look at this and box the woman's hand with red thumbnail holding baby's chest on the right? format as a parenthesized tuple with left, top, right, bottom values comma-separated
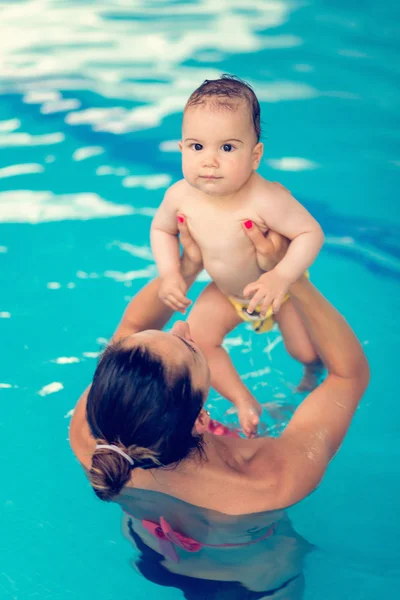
(243, 221, 290, 271)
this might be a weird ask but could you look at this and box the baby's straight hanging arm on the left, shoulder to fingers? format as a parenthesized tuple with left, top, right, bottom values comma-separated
(150, 184, 191, 312)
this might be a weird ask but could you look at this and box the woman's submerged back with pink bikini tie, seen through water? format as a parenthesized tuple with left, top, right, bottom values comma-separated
(116, 487, 311, 592)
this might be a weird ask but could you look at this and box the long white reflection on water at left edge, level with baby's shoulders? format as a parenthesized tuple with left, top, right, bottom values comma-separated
(0, 190, 135, 223)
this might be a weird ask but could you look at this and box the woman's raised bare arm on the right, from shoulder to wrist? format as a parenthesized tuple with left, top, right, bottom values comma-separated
(278, 276, 369, 505)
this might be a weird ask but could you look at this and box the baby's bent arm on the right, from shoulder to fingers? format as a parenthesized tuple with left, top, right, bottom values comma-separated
(244, 183, 324, 312)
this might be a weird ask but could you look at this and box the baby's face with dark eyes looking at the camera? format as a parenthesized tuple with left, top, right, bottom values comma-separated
(180, 103, 262, 196)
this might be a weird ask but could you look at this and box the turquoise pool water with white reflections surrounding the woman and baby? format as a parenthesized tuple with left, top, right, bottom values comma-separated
(0, 0, 400, 600)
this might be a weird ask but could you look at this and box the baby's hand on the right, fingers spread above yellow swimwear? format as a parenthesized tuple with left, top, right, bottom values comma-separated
(243, 269, 292, 316)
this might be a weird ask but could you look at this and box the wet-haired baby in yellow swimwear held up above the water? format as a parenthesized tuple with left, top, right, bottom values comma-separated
(151, 75, 324, 436)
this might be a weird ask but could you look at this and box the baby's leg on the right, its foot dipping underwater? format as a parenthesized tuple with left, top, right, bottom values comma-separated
(275, 298, 323, 392)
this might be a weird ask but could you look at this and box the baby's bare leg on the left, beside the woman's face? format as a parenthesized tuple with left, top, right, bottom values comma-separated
(188, 283, 261, 436)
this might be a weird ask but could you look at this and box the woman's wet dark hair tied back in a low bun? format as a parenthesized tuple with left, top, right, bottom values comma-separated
(86, 342, 205, 500)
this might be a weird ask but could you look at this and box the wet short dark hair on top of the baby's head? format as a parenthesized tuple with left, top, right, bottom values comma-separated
(185, 74, 261, 142)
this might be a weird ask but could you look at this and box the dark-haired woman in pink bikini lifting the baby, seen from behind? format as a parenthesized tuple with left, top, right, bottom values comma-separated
(70, 224, 369, 600)
